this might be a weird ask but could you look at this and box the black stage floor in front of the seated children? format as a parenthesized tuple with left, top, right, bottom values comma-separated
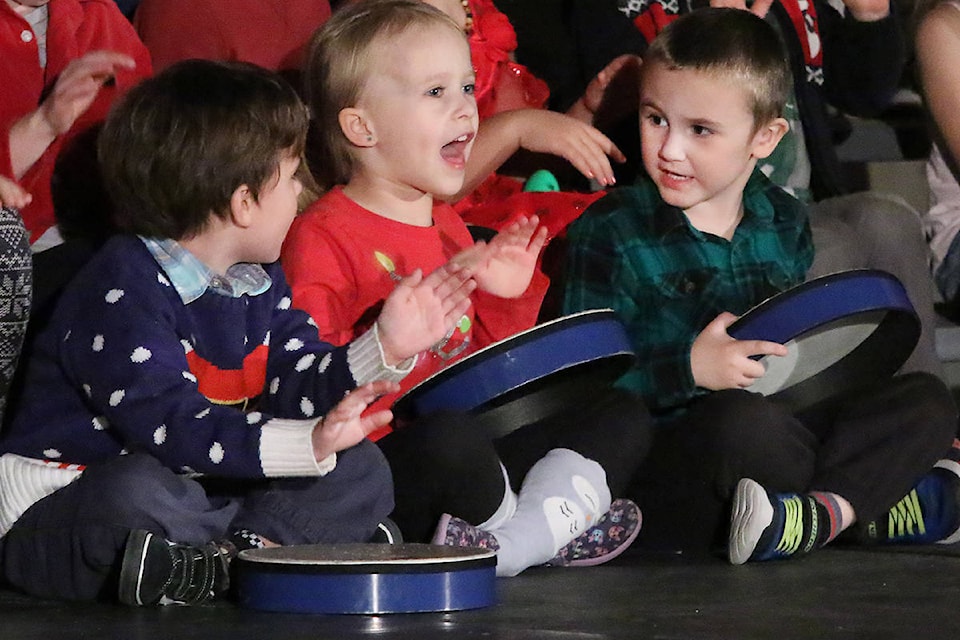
(0, 547, 960, 640)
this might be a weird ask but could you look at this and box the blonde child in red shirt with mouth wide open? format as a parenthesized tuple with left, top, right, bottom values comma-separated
(282, 0, 649, 576)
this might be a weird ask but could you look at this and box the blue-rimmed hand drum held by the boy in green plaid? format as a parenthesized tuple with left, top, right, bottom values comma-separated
(727, 269, 920, 411)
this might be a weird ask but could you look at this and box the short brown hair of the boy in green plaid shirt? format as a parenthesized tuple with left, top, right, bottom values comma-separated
(641, 7, 791, 129)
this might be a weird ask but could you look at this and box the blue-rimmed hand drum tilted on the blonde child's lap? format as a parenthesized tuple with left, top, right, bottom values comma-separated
(393, 309, 636, 437)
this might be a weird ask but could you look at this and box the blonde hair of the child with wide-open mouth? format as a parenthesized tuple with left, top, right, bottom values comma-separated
(303, 0, 465, 188)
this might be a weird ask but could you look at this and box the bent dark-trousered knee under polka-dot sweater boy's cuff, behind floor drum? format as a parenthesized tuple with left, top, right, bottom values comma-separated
(228, 440, 393, 545)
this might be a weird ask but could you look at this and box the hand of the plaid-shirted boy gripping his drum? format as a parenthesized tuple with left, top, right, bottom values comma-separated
(690, 311, 787, 391)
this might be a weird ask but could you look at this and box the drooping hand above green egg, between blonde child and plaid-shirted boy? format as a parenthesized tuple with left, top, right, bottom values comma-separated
(513, 109, 626, 186)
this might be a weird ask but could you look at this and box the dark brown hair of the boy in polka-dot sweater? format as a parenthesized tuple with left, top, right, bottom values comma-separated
(98, 60, 308, 240)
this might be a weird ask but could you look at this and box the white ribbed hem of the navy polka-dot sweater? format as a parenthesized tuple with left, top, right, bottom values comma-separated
(0, 453, 81, 538)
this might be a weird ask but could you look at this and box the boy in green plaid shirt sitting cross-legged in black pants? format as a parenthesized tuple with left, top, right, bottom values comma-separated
(563, 8, 960, 564)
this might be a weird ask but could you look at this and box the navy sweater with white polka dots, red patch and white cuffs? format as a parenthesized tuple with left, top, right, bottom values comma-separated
(0, 236, 395, 477)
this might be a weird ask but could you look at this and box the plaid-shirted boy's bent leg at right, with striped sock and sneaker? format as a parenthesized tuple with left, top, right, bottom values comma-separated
(729, 373, 956, 564)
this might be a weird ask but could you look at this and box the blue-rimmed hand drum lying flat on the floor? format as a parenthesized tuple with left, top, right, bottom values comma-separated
(234, 543, 497, 614)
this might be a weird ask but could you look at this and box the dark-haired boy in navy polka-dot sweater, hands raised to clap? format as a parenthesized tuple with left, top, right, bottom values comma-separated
(0, 60, 475, 605)
